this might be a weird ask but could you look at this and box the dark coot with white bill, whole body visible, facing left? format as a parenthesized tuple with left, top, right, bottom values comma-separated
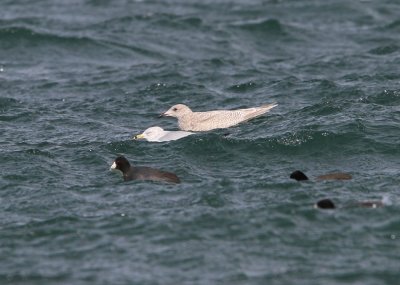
(111, 156, 181, 183)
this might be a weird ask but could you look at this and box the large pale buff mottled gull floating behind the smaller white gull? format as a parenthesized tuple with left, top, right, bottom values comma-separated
(161, 104, 278, 132)
